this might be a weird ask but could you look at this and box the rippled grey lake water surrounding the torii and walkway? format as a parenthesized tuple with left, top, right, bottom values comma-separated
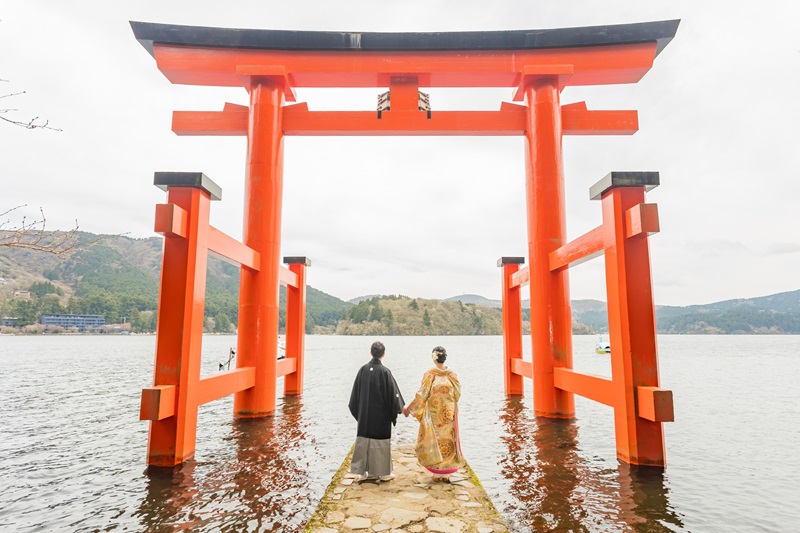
(0, 336, 800, 532)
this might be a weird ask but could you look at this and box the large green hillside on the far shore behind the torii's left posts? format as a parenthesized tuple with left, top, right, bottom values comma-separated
(0, 233, 352, 332)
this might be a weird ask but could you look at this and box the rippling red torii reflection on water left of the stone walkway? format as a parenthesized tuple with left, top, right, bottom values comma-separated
(134, 396, 317, 531)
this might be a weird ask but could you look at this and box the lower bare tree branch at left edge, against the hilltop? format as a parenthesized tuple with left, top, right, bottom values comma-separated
(0, 205, 102, 258)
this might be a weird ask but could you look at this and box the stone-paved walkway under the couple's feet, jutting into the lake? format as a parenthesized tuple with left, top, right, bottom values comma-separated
(305, 446, 508, 533)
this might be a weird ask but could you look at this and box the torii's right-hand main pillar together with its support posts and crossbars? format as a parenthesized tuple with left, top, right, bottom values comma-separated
(520, 78, 673, 466)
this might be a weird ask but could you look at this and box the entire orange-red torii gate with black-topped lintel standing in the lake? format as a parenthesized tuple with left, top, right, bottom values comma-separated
(131, 20, 679, 466)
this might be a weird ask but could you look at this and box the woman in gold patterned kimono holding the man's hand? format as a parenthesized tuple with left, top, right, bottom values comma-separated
(403, 346, 465, 481)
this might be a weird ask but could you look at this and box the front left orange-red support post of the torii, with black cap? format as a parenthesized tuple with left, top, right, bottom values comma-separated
(140, 172, 221, 467)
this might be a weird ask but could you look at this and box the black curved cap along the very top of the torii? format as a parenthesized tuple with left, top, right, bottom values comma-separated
(130, 20, 680, 55)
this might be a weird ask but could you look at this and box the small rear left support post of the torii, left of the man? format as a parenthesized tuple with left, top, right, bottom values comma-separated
(283, 257, 311, 395)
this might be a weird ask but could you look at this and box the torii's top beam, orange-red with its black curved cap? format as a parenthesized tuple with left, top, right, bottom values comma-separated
(131, 20, 680, 88)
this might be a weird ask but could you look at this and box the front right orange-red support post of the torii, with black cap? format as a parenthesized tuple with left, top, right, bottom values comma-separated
(591, 172, 672, 466)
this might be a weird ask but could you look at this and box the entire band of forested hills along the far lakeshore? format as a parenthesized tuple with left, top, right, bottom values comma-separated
(0, 233, 800, 335)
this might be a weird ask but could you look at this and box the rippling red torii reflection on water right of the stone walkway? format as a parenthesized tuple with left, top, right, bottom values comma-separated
(498, 397, 683, 531)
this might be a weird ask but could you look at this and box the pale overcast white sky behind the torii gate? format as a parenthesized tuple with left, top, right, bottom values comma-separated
(0, 0, 800, 305)
